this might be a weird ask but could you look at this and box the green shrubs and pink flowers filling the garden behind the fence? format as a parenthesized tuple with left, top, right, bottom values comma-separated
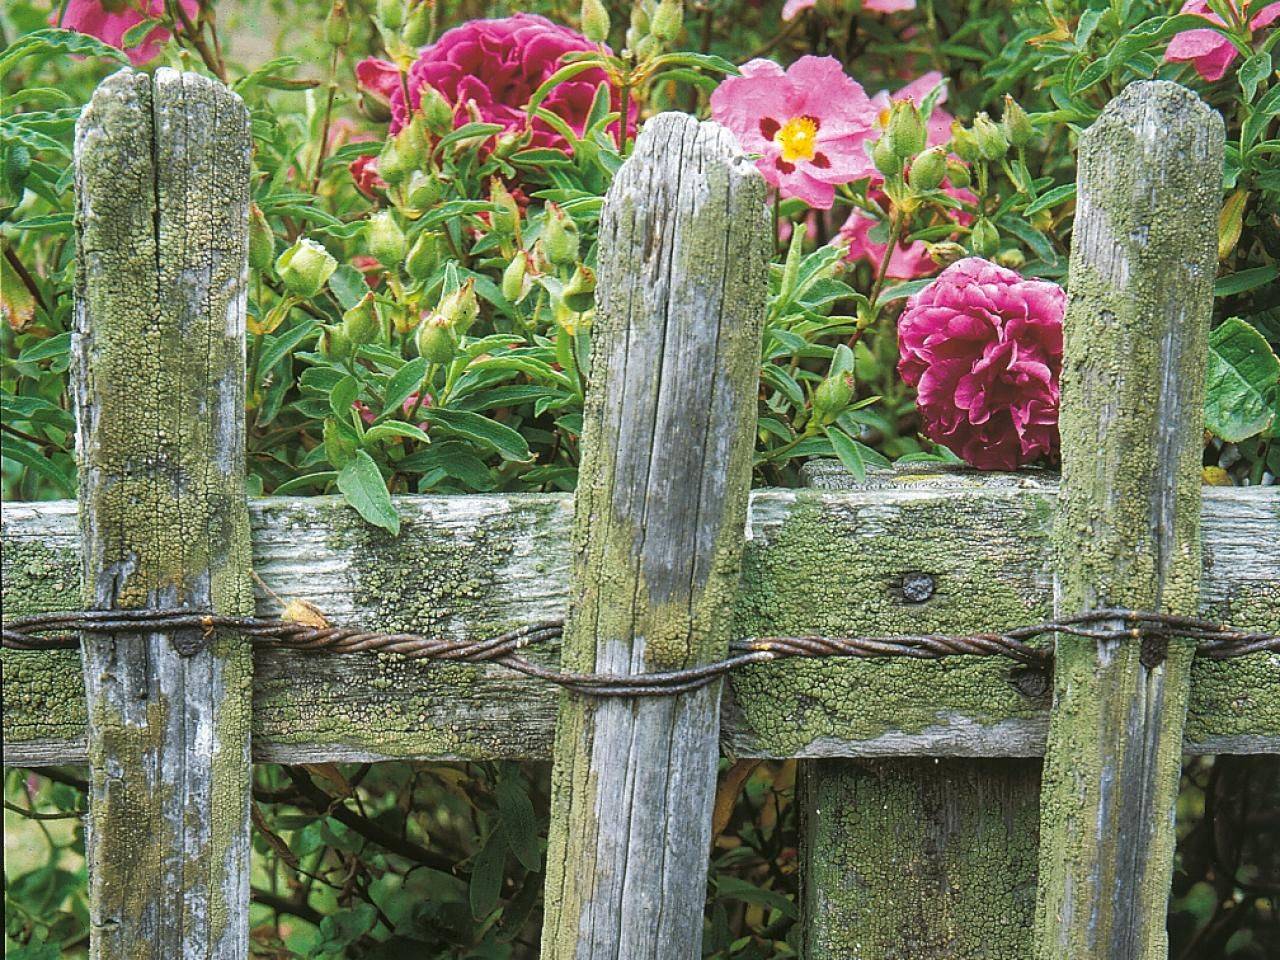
(0, 0, 1280, 960)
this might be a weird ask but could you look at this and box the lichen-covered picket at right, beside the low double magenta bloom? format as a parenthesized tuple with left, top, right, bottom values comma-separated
(1037, 82, 1224, 960)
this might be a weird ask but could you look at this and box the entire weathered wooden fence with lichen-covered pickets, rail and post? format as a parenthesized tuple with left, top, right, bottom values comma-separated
(0, 70, 1280, 960)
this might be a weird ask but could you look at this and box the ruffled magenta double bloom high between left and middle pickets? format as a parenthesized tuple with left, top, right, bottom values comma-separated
(356, 13, 635, 148)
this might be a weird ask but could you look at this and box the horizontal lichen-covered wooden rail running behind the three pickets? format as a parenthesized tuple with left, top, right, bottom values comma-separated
(0, 481, 1280, 765)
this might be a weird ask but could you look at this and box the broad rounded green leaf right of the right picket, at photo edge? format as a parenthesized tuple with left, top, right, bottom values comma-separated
(1204, 316, 1280, 443)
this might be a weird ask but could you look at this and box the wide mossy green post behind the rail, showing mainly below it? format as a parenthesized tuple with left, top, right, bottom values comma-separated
(796, 461, 1047, 960)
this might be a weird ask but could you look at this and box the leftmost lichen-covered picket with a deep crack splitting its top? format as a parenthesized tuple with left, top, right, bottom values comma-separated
(73, 69, 253, 960)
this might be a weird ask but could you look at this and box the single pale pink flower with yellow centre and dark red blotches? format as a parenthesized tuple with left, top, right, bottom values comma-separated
(712, 56, 876, 210)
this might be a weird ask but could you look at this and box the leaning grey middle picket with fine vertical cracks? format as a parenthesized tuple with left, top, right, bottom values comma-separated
(543, 114, 768, 960)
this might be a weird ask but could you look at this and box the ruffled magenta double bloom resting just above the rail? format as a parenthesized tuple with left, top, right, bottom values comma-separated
(897, 257, 1066, 470)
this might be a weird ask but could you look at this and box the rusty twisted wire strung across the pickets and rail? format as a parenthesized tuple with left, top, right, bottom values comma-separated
(3, 604, 1280, 696)
